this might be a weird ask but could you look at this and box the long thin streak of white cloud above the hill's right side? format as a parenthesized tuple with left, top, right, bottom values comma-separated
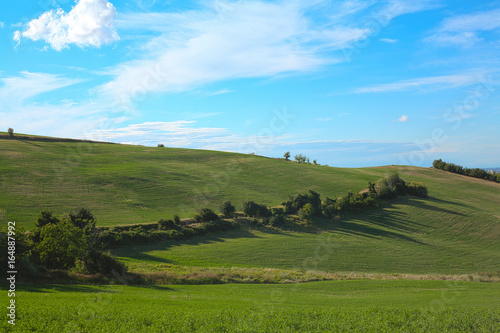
(352, 73, 482, 94)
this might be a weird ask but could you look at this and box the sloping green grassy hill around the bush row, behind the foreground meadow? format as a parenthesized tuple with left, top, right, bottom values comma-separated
(0, 134, 500, 274)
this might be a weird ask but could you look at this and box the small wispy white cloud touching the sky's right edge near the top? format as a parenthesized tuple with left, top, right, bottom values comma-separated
(425, 8, 500, 48)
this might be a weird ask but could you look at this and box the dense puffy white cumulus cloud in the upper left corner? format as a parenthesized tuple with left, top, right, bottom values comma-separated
(14, 0, 119, 51)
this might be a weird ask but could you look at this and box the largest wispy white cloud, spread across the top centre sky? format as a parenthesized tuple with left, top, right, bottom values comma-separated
(102, 1, 378, 104)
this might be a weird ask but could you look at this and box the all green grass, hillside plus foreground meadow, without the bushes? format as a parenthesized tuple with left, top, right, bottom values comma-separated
(0, 136, 500, 332)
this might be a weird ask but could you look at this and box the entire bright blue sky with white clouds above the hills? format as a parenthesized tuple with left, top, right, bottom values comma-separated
(0, 0, 500, 167)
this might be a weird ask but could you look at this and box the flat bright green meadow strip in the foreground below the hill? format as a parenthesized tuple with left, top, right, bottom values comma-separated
(0, 280, 500, 332)
